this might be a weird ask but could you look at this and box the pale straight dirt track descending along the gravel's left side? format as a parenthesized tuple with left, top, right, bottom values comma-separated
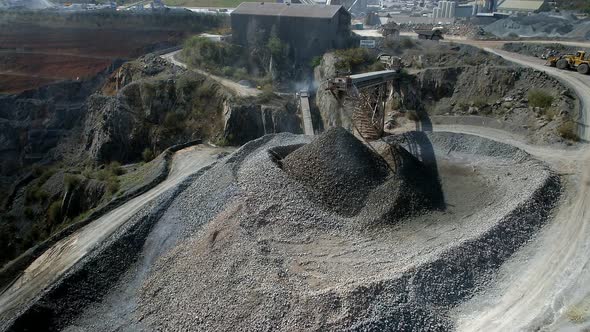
(0, 145, 231, 330)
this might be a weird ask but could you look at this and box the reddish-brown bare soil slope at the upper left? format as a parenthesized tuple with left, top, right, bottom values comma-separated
(0, 25, 184, 93)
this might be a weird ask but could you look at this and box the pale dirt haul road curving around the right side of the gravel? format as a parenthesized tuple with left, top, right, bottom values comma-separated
(439, 48, 590, 331)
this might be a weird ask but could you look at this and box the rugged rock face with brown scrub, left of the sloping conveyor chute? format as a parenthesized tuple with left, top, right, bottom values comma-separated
(83, 78, 301, 160)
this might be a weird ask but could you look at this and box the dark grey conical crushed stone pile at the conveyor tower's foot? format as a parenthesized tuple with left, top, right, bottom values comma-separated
(282, 127, 389, 216)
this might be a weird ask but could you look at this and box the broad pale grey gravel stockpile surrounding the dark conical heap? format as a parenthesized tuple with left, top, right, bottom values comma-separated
(10, 131, 559, 331)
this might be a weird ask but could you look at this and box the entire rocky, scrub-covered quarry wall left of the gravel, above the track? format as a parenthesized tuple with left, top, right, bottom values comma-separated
(0, 55, 302, 270)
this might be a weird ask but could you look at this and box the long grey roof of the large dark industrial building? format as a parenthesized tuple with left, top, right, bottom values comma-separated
(231, 2, 343, 18)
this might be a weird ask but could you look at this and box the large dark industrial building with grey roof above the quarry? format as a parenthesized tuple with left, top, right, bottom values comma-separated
(231, 2, 351, 62)
